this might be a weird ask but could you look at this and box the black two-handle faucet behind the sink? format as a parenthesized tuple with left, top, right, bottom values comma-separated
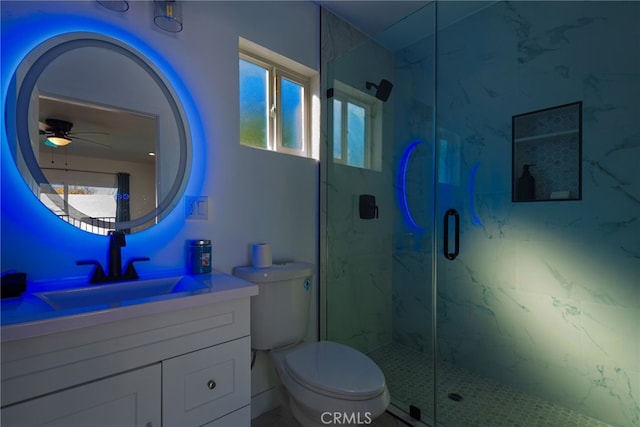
(76, 230, 149, 283)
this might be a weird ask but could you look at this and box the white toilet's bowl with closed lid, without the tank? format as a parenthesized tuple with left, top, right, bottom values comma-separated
(270, 341, 390, 427)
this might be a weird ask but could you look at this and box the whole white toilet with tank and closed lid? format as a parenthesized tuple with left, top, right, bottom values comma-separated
(233, 262, 390, 427)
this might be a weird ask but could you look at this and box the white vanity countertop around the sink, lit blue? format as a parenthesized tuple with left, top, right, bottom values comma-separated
(0, 271, 258, 342)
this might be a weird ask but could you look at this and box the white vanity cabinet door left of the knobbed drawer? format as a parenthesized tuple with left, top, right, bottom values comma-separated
(2, 363, 161, 427)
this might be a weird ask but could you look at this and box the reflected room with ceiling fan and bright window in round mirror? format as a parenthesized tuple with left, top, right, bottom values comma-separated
(38, 94, 156, 234)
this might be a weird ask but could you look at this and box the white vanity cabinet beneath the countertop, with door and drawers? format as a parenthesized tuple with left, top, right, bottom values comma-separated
(0, 289, 257, 427)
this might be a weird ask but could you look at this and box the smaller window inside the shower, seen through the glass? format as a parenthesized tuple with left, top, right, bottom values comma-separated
(331, 81, 382, 170)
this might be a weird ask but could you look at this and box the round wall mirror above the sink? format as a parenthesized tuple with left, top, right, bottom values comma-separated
(6, 33, 190, 234)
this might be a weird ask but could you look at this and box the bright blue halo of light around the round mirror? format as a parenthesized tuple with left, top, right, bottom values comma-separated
(0, 8, 207, 277)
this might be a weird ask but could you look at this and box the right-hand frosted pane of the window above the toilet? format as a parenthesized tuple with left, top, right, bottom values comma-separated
(280, 78, 304, 150)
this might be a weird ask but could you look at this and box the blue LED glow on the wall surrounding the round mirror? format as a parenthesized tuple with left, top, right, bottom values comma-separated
(0, 9, 205, 280)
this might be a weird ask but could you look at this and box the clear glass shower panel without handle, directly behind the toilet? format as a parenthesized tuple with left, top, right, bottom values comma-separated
(322, 3, 436, 422)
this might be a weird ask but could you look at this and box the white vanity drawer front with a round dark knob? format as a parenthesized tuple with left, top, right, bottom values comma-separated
(162, 337, 251, 427)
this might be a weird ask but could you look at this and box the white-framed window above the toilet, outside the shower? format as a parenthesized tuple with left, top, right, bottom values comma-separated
(239, 38, 317, 158)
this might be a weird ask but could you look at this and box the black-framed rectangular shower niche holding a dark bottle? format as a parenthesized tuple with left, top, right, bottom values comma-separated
(511, 102, 582, 202)
